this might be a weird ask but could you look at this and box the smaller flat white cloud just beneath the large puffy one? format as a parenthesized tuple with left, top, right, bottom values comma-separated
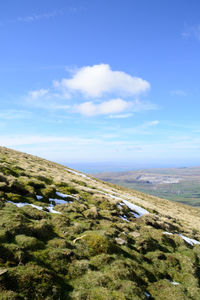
(75, 98, 131, 117)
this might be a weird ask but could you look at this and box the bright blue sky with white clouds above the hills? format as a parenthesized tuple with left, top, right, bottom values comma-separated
(0, 0, 200, 169)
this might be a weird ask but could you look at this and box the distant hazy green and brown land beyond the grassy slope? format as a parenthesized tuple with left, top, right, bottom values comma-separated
(95, 167, 200, 206)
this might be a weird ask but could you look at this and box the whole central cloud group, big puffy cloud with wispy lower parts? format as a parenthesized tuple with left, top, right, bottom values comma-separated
(25, 64, 153, 119)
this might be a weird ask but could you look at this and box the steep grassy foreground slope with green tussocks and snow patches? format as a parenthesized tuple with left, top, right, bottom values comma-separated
(0, 147, 200, 300)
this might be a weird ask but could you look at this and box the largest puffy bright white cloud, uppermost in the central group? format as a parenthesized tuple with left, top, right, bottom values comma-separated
(56, 64, 150, 97)
